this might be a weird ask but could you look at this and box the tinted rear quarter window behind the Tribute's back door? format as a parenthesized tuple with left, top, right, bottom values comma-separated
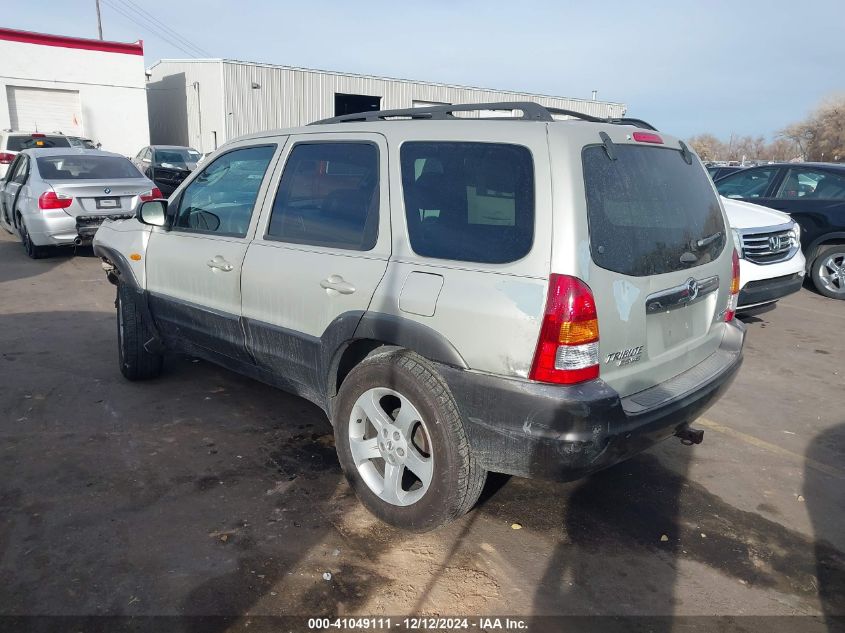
(400, 142, 534, 264)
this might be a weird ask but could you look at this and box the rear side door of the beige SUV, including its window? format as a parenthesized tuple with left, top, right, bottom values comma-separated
(242, 133, 391, 398)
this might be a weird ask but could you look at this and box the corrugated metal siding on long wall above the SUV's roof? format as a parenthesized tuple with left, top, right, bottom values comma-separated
(223, 61, 625, 138)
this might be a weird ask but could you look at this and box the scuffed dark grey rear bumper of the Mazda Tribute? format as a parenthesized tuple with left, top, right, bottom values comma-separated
(440, 320, 745, 481)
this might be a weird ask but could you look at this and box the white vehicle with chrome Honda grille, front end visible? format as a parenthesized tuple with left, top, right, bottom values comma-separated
(722, 197, 806, 312)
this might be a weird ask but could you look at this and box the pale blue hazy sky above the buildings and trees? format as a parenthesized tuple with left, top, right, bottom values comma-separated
(0, 0, 845, 138)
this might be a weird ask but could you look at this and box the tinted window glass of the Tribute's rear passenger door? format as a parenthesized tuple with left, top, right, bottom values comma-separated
(267, 142, 379, 251)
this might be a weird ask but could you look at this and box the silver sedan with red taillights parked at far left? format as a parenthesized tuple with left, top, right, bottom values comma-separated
(0, 148, 162, 258)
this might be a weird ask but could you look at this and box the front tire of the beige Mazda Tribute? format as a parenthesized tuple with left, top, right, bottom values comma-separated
(117, 284, 164, 381)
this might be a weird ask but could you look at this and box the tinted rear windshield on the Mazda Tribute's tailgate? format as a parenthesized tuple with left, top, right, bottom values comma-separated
(583, 144, 726, 277)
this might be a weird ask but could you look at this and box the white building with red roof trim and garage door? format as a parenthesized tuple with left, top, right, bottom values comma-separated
(0, 28, 149, 155)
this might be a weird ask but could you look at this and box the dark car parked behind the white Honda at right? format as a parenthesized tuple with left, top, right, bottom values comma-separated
(716, 163, 845, 299)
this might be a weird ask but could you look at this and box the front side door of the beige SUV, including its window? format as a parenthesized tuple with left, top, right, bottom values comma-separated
(147, 141, 279, 362)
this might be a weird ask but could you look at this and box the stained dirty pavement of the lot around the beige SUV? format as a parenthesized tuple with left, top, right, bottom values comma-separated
(0, 228, 845, 628)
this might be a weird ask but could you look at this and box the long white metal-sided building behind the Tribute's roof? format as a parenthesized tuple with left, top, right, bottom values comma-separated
(147, 59, 625, 152)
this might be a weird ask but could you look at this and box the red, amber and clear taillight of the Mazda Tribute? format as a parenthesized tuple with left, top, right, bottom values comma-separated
(528, 274, 599, 385)
